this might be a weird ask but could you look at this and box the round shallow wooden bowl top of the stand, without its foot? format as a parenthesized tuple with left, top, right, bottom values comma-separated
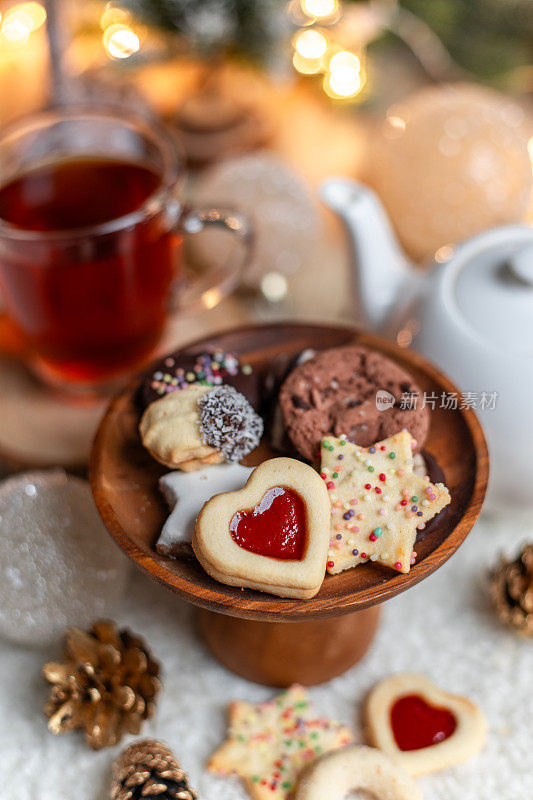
(90, 324, 489, 683)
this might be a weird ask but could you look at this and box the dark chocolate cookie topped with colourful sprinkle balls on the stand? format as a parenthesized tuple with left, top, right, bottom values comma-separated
(138, 348, 259, 411)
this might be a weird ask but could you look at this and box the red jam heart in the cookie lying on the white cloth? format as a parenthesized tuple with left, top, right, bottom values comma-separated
(390, 694, 457, 750)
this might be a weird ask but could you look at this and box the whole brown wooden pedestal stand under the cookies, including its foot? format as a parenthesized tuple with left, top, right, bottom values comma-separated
(90, 324, 488, 686)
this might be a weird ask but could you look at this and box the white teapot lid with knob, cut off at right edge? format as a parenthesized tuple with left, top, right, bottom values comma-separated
(450, 225, 533, 359)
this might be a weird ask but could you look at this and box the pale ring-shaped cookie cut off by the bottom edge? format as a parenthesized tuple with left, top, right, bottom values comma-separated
(295, 745, 422, 800)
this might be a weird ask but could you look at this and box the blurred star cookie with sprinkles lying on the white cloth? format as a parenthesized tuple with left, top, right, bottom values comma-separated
(207, 684, 352, 800)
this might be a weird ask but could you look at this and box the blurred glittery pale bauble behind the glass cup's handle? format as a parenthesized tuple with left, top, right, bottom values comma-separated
(192, 152, 320, 290)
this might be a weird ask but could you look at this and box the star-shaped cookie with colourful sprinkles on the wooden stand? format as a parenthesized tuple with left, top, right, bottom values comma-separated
(321, 430, 450, 574)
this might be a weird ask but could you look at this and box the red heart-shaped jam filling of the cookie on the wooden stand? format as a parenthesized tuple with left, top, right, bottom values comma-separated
(229, 486, 307, 561)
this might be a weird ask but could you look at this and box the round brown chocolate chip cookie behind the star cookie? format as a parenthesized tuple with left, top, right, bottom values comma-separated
(279, 346, 429, 461)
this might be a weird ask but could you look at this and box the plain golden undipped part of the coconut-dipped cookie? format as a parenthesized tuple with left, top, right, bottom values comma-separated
(139, 383, 222, 472)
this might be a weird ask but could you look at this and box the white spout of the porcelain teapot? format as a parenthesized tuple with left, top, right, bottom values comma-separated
(320, 178, 416, 330)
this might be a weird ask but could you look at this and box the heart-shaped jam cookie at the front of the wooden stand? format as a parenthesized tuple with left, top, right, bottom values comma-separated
(192, 458, 331, 599)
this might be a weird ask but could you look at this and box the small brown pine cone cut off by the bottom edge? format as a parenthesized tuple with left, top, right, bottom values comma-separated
(111, 739, 197, 800)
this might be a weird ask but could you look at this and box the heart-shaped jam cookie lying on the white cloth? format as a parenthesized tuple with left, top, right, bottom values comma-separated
(365, 673, 487, 776)
